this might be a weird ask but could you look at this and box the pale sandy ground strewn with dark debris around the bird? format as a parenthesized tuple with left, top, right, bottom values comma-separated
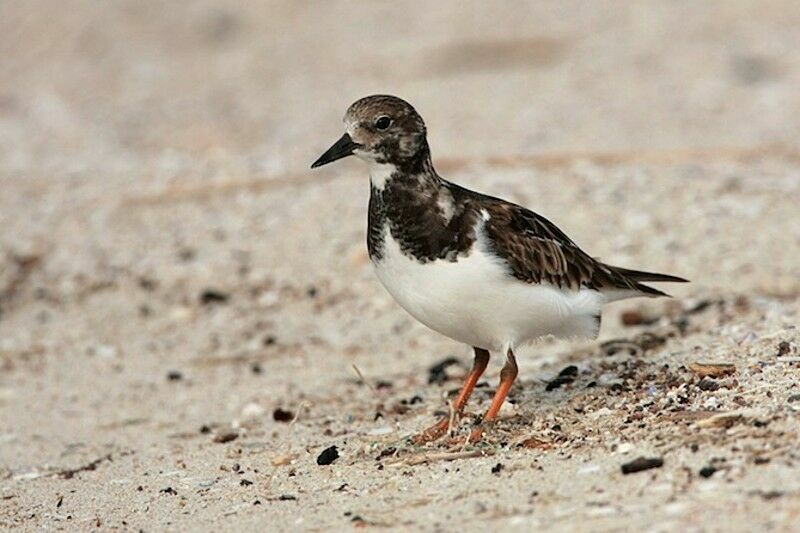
(0, 0, 800, 531)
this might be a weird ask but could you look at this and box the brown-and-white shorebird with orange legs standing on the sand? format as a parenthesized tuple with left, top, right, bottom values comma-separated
(311, 94, 687, 444)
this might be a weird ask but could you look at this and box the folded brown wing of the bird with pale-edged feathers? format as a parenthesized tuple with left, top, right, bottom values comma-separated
(481, 201, 664, 295)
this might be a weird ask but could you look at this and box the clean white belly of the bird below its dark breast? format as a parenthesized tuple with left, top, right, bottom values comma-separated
(374, 231, 606, 351)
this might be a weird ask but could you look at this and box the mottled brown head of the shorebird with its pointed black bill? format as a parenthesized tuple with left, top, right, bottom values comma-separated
(311, 95, 428, 168)
